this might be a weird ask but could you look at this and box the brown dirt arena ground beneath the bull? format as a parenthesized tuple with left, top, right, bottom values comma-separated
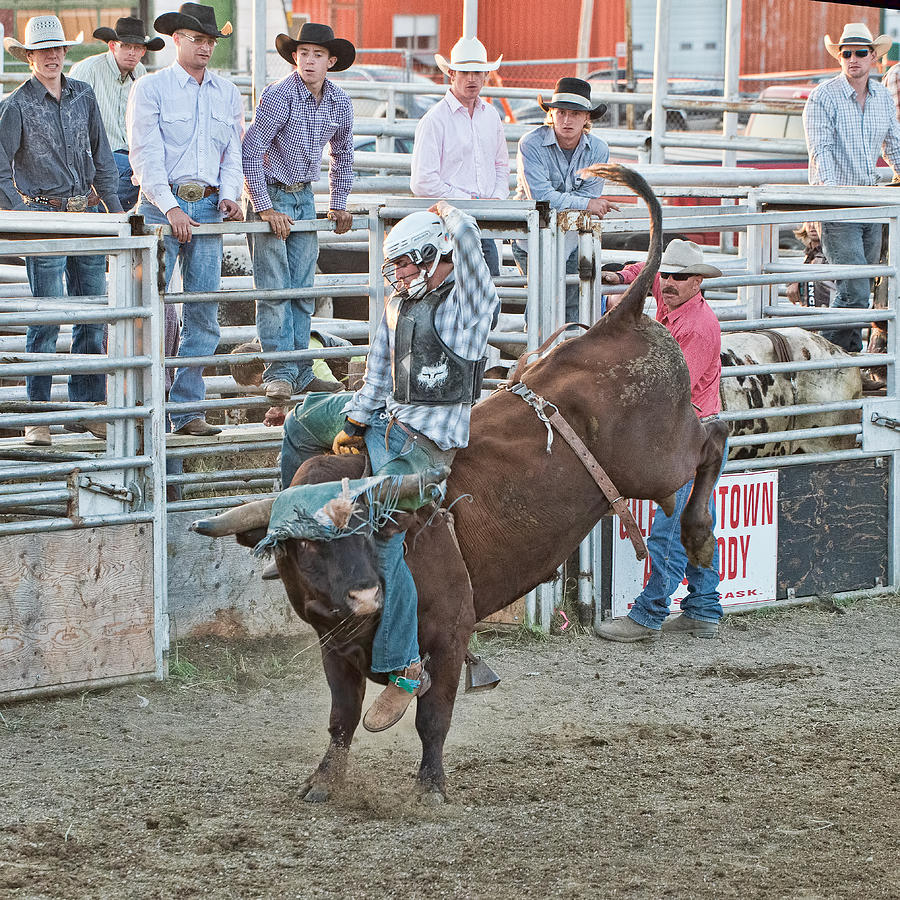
(0, 597, 900, 900)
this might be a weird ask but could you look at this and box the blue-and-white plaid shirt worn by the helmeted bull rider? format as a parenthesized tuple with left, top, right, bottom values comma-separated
(347, 200, 499, 450)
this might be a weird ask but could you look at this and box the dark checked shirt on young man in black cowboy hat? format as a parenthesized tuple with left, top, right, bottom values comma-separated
(241, 72, 353, 213)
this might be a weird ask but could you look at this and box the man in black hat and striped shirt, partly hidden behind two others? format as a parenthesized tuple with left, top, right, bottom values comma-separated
(69, 17, 166, 209)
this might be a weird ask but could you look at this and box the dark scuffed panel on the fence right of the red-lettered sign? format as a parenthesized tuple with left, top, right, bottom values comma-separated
(778, 459, 890, 599)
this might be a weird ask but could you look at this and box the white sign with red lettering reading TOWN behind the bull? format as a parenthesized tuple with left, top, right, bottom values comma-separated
(612, 471, 778, 616)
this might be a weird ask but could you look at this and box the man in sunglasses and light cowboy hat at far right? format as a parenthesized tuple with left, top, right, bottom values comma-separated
(803, 22, 900, 352)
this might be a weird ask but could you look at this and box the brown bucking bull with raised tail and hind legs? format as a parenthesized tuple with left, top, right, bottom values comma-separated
(192, 166, 727, 801)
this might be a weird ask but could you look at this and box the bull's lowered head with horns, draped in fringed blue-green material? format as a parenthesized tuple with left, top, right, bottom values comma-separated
(191, 467, 449, 626)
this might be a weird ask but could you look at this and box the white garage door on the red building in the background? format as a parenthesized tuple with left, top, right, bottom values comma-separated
(632, 0, 725, 77)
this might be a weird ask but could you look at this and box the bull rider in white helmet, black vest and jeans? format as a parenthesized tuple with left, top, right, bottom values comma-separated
(281, 200, 499, 731)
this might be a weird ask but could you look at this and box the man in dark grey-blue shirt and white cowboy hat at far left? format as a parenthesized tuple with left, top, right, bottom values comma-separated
(0, 16, 122, 446)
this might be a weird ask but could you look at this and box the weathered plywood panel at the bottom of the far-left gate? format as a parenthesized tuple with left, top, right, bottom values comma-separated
(0, 525, 156, 699)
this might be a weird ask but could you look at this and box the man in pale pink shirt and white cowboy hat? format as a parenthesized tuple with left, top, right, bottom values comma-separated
(409, 37, 509, 275)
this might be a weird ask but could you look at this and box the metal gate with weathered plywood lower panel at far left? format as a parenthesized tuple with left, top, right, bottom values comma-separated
(0, 213, 168, 700)
